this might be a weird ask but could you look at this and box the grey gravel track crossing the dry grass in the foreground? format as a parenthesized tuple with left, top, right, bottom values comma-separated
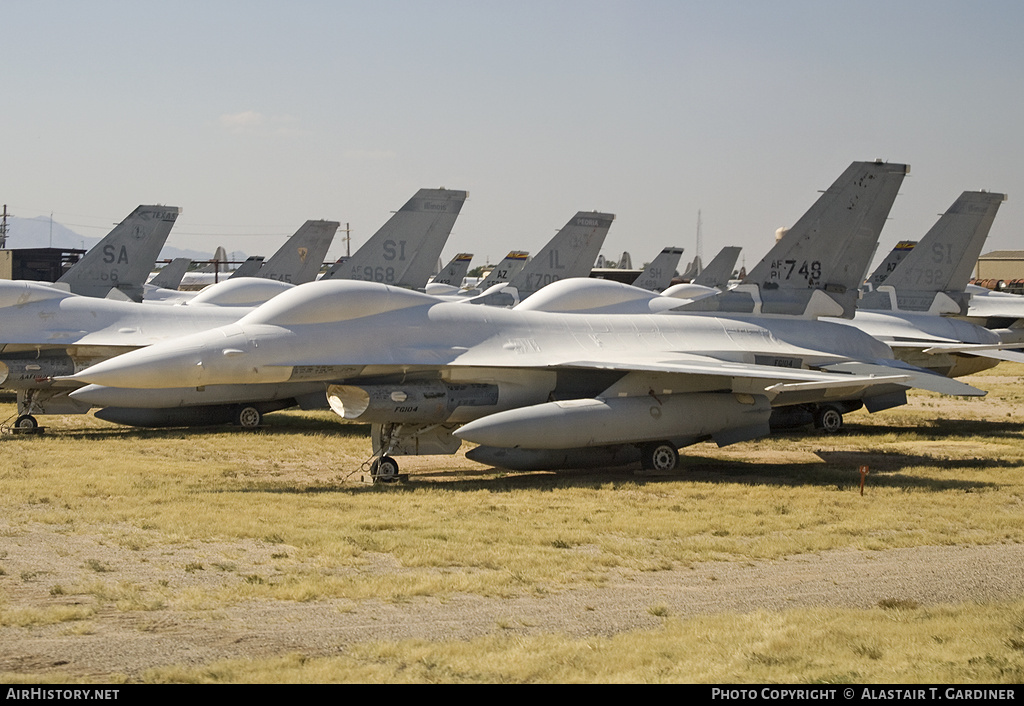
(0, 544, 1024, 677)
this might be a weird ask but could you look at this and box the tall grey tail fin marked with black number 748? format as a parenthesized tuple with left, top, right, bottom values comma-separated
(680, 161, 909, 319)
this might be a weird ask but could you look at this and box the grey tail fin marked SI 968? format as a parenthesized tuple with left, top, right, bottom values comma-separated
(322, 189, 468, 289)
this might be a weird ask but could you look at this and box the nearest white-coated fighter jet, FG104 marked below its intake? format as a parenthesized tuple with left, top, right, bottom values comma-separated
(72, 163, 983, 477)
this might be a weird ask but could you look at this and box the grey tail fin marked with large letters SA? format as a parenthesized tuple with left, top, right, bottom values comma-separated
(57, 206, 181, 301)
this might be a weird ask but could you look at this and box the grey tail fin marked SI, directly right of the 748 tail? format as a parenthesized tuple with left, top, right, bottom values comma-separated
(860, 192, 1007, 315)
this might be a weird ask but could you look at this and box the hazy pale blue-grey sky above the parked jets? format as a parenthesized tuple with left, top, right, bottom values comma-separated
(0, 0, 1024, 265)
